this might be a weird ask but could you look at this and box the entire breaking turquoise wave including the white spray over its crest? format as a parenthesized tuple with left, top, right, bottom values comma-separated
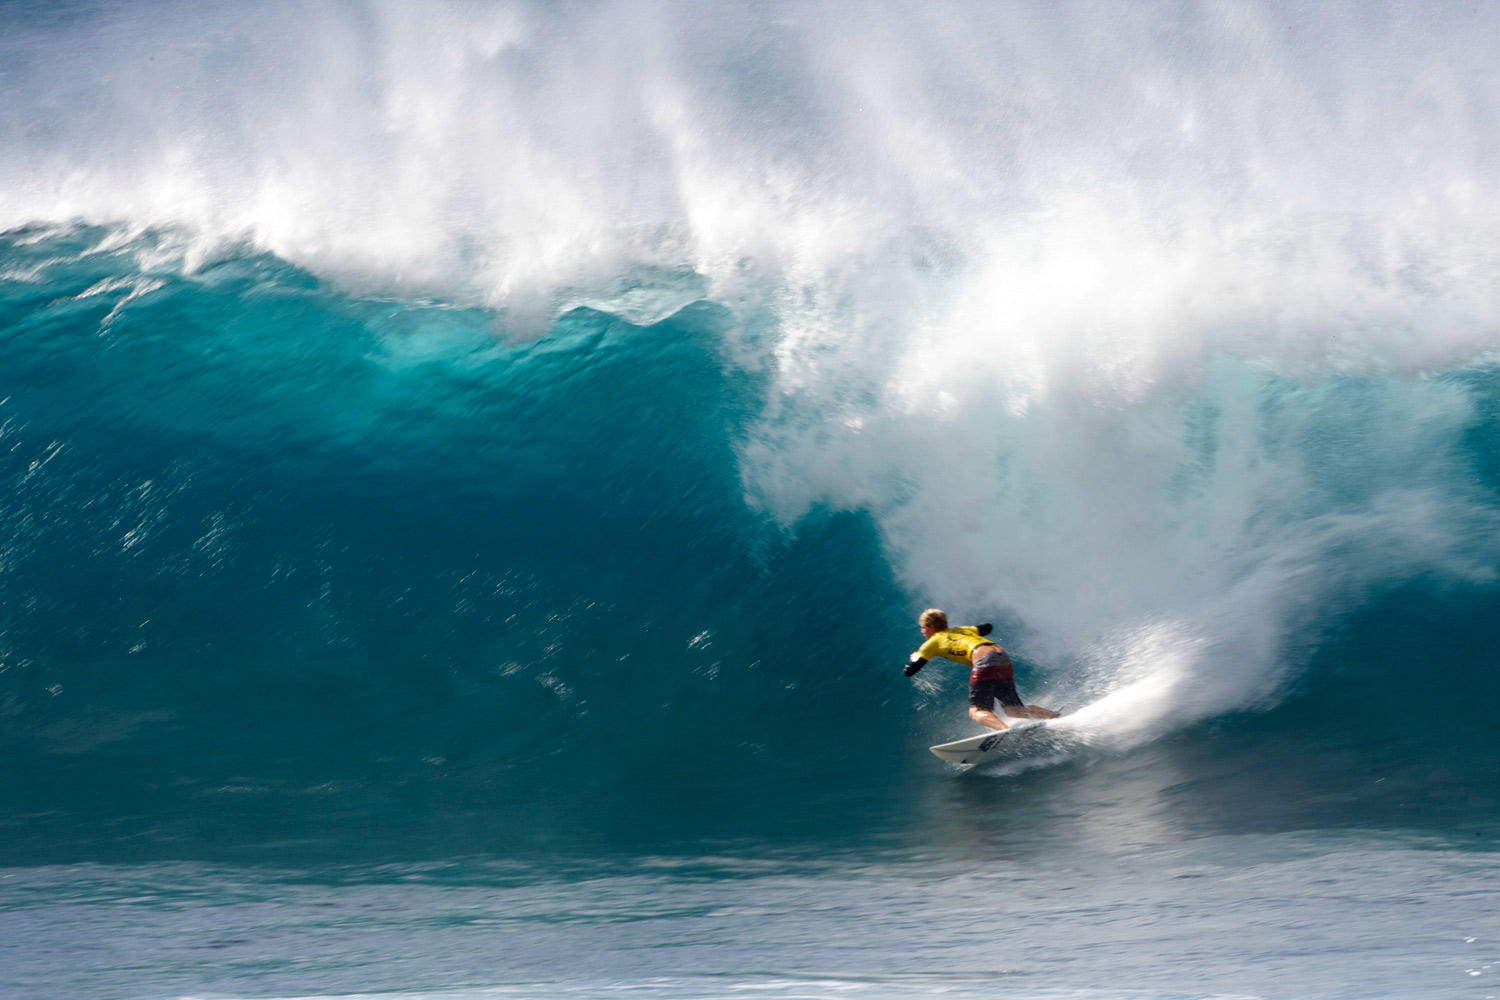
(0, 3, 1500, 850)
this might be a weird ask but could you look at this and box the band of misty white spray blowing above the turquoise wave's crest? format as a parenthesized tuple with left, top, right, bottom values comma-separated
(0, 3, 1497, 344)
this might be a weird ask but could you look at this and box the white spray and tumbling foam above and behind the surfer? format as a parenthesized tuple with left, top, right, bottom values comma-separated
(11, 3, 1500, 727)
